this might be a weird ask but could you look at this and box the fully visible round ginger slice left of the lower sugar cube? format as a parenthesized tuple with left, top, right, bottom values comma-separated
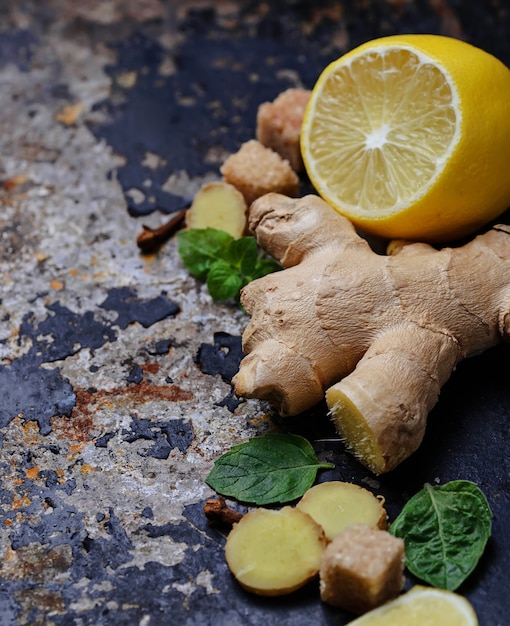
(225, 506, 326, 596)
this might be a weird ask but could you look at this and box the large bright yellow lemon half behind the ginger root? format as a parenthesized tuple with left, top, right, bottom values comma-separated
(301, 35, 510, 241)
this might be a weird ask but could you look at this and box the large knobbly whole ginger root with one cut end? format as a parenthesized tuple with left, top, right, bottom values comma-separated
(232, 193, 510, 474)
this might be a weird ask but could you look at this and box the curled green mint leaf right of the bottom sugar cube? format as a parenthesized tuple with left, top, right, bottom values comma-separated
(390, 480, 492, 591)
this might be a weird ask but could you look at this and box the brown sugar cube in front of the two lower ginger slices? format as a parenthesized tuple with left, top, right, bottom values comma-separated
(320, 524, 404, 614)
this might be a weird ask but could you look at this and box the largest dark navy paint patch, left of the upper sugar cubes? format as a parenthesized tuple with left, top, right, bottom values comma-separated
(91, 23, 328, 217)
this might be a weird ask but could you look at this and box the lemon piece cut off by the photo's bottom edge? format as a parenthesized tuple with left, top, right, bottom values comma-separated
(349, 585, 478, 626)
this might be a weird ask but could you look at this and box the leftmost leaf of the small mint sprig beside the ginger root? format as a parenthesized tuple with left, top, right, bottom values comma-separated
(177, 228, 234, 280)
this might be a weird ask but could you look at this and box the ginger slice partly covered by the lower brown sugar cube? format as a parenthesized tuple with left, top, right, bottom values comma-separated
(297, 481, 388, 541)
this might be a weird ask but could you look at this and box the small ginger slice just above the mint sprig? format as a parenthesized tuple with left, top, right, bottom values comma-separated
(186, 181, 247, 239)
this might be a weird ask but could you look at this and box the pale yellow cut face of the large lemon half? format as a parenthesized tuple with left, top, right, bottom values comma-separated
(310, 48, 460, 214)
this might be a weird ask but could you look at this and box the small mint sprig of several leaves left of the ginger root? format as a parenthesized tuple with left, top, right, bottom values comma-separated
(177, 228, 281, 301)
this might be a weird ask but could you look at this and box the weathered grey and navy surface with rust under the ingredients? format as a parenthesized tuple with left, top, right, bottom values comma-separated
(0, 0, 510, 626)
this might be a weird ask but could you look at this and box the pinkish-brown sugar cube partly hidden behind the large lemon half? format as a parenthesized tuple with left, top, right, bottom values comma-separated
(256, 88, 311, 172)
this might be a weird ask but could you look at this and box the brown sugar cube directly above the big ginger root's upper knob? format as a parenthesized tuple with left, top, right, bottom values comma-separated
(221, 139, 299, 206)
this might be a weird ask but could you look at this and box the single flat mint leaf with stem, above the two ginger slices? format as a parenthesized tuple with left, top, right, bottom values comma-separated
(206, 434, 334, 506)
